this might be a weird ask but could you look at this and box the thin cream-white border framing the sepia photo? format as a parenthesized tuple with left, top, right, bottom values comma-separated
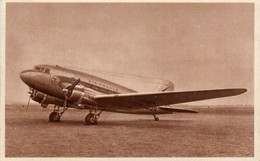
(0, 0, 260, 161)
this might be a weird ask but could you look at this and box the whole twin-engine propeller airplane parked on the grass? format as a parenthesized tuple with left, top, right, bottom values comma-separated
(20, 65, 247, 125)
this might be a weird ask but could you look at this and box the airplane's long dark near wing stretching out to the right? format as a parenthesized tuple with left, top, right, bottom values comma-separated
(94, 88, 247, 108)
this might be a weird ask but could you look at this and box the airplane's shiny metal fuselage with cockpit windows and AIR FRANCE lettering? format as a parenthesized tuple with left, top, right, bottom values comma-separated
(20, 65, 136, 98)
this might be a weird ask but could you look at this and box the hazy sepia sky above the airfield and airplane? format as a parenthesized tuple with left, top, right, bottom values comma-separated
(5, 3, 254, 105)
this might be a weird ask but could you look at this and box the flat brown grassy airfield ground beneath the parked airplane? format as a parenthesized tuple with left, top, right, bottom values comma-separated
(5, 105, 254, 157)
